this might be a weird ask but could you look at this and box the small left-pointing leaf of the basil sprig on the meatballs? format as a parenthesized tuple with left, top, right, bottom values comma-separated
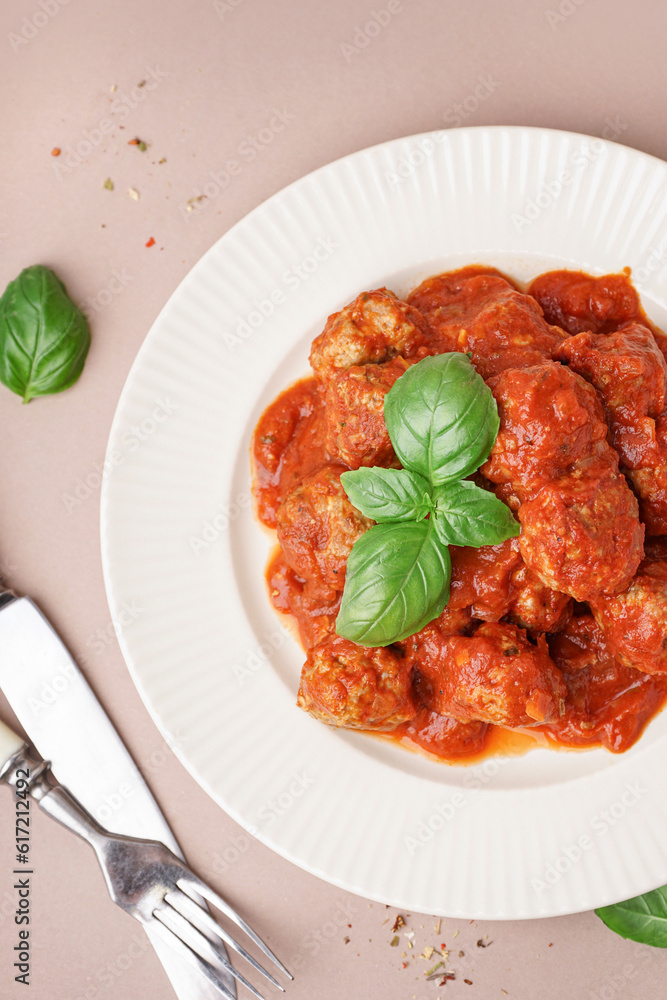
(340, 468, 431, 521)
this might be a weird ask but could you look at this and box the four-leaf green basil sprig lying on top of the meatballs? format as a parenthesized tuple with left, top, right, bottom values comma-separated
(336, 353, 520, 646)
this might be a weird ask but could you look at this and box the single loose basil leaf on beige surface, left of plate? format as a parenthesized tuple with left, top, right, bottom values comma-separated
(0, 264, 90, 403)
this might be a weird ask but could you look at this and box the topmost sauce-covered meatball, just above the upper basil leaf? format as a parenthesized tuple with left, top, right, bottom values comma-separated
(408, 274, 566, 379)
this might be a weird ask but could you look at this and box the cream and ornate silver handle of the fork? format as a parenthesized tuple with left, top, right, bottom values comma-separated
(0, 722, 106, 849)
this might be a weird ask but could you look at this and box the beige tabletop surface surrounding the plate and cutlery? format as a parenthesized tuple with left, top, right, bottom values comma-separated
(0, 0, 667, 1000)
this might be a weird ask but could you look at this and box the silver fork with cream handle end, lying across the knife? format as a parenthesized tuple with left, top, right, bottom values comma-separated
(0, 722, 294, 1000)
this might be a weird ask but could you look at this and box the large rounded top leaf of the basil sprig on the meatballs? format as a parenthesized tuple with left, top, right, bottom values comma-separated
(384, 353, 500, 486)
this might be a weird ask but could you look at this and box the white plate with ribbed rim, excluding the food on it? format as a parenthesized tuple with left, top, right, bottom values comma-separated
(102, 127, 667, 918)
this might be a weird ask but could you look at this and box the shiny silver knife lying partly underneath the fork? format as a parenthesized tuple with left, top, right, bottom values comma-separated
(0, 591, 236, 1000)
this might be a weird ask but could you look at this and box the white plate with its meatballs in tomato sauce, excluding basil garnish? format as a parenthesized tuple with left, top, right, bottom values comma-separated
(102, 128, 667, 919)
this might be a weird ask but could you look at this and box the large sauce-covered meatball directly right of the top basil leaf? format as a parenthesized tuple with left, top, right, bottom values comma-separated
(481, 361, 618, 498)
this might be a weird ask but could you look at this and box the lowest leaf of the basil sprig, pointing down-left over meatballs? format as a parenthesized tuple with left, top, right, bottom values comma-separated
(336, 520, 451, 646)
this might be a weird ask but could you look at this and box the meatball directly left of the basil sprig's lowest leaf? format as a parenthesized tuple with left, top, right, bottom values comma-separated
(276, 465, 373, 592)
